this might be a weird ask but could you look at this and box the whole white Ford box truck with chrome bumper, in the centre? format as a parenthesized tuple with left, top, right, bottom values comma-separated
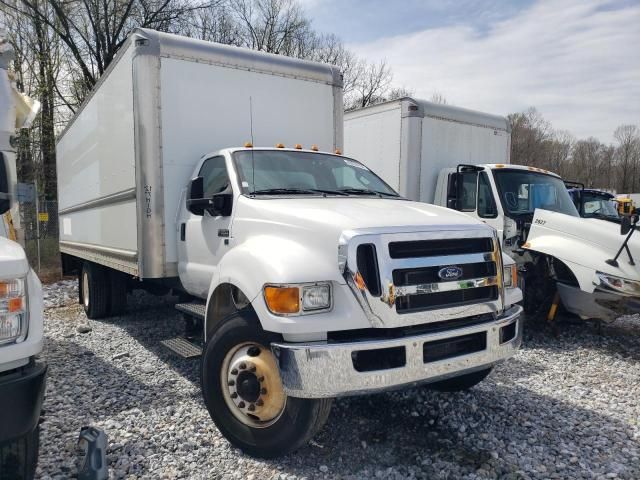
(57, 30, 522, 457)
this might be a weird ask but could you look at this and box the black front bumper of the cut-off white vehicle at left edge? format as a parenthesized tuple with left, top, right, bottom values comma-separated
(0, 361, 47, 443)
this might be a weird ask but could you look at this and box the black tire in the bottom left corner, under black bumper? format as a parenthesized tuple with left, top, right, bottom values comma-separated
(0, 427, 40, 480)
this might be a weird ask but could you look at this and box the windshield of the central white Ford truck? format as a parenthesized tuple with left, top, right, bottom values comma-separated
(233, 150, 398, 197)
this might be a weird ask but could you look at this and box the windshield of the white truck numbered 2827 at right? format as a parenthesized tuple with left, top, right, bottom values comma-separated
(493, 169, 578, 217)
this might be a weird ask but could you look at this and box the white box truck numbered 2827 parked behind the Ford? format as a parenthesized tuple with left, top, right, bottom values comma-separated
(344, 97, 640, 320)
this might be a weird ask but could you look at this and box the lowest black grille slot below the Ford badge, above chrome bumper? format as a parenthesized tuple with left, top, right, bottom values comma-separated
(396, 286, 498, 314)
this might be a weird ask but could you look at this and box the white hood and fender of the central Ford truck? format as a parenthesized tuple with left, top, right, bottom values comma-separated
(228, 196, 492, 288)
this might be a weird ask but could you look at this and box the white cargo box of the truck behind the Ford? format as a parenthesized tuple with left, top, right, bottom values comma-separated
(344, 97, 511, 203)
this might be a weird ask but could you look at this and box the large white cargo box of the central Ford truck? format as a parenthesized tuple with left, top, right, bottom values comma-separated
(57, 29, 342, 278)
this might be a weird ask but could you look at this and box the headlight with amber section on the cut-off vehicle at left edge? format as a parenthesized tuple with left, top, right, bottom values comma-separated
(0, 279, 27, 344)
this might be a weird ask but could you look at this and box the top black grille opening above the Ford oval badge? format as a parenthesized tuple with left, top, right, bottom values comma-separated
(389, 238, 493, 258)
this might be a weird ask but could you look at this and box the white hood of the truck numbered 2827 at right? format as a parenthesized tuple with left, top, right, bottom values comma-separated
(527, 209, 640, 286)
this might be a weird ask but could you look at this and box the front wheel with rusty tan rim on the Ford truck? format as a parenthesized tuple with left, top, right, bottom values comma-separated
(201, 312, 332, 458)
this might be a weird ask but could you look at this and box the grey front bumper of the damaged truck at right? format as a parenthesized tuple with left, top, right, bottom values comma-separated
(558, 283, 640, 321)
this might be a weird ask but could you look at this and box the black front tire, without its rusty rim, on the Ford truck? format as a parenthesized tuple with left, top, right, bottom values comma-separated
(201, 312, 333, 458)
